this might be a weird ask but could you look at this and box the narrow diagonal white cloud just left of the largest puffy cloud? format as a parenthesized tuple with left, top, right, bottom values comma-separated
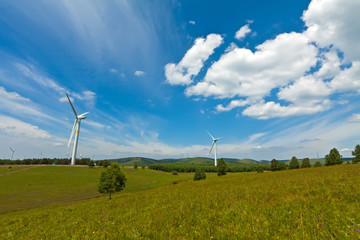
(165, 34, 223, 85)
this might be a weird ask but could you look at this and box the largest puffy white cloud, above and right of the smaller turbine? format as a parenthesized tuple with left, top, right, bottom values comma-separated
(186, 32, 318, 99)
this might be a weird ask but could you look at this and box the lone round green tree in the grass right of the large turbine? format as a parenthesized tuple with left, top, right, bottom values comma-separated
(98, 162, 126, 199)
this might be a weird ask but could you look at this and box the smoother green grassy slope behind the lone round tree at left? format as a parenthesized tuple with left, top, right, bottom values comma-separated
(0, 166, 193, 213)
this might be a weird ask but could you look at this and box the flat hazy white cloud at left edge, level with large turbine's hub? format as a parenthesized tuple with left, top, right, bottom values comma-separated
(0, 115, 50, 138)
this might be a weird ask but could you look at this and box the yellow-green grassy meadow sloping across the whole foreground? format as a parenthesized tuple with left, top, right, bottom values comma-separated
(0, 164, 360, 239)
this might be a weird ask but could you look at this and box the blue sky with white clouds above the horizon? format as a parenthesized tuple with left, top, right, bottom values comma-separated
(0, 0, 360, 160)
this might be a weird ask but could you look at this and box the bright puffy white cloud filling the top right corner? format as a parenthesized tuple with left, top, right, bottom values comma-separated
(302, 0, 360, 61)
